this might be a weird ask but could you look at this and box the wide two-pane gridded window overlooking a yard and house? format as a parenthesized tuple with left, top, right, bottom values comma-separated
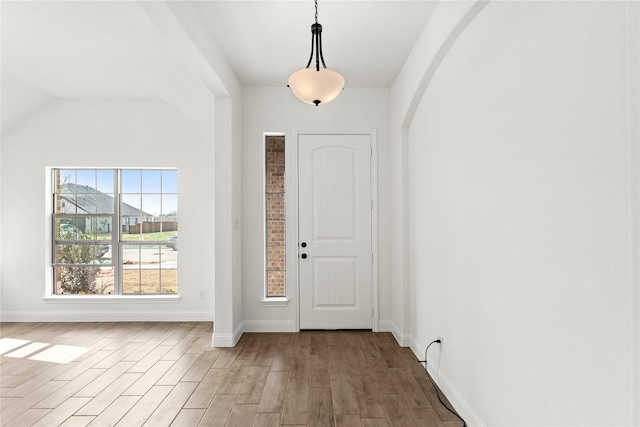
(52, 169, 178, 294)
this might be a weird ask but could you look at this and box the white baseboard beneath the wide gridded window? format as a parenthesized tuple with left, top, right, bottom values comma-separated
(0, 308, 213, 322)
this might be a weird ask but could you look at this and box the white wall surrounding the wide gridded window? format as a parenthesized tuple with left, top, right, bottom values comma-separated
(1, 99, 214, 321)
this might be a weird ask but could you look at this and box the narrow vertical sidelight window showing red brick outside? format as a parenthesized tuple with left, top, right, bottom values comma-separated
(265, 136, 286, 297)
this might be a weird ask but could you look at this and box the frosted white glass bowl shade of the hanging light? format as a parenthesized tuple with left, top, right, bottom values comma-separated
(289, 68, 344, 106)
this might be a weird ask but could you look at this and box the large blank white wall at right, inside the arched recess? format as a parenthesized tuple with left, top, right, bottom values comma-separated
(407, 1, 639, 426)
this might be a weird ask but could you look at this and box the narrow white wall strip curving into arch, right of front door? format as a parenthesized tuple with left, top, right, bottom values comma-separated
(389, 0, 487, 346)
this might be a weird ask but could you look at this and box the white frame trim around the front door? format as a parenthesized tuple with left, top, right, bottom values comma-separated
(292, 129, 379, 332)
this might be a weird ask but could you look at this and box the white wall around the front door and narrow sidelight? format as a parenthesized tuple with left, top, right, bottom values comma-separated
(241, 86, 391, 331)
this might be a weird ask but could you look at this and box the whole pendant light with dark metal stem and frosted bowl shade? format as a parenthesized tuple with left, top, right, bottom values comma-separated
(288, 0, 344, 107)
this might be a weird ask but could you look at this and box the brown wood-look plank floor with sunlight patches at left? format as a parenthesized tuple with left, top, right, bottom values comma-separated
(0, 322, 462, 427)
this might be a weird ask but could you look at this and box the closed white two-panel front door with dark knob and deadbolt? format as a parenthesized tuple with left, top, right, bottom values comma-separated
(298, 134, 373, 329)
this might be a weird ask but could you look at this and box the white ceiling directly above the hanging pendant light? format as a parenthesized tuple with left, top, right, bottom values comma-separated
(190, 0, 436, 87)
